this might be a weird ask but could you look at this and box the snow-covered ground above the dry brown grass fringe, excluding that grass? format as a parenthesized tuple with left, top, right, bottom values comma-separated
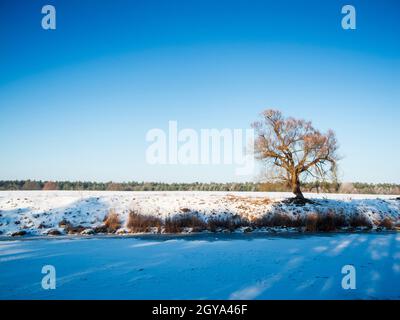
(0, 191, 400, 236)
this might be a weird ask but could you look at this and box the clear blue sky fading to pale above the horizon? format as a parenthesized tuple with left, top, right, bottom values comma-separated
(0, 0, 400, 183)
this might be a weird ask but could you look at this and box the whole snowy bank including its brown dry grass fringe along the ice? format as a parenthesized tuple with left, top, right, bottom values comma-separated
(0, 191, 400, 236)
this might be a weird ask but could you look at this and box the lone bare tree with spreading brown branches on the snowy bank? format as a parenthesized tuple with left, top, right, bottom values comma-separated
(252, 110, 339, 199)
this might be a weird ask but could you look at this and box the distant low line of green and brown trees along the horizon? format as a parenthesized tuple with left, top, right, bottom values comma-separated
(0, 180, 400, 195)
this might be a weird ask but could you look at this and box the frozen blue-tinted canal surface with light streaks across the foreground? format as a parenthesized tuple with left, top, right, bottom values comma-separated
(0, 233, 400, 299)
